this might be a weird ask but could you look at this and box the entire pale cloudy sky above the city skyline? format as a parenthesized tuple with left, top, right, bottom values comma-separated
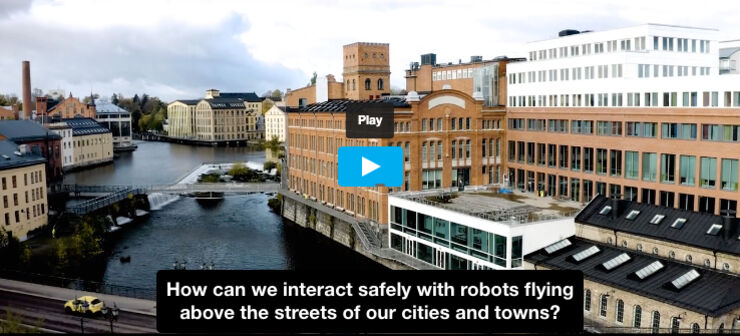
(0, 0, 740, 101)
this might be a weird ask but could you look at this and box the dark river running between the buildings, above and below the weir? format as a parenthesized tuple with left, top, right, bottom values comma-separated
(64, 142, 382, 289)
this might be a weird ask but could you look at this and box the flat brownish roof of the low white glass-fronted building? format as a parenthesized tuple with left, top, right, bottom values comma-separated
(391, 187, 581, 223)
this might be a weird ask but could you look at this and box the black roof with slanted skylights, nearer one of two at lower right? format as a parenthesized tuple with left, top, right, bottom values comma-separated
(525, 237, 740, 316)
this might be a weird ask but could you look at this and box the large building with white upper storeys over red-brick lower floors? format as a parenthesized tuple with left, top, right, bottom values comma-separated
(504, 24, 740, 214)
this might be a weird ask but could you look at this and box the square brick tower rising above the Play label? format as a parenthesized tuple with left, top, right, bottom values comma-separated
(342, 42, 391, 100)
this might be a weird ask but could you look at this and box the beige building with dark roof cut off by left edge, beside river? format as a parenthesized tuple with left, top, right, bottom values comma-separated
(0, 140, 48, 241)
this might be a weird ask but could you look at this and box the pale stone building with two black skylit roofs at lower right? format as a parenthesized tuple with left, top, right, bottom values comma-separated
(525, 195, 740, 333)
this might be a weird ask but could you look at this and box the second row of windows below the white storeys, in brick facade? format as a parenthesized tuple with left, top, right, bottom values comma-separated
(508, 141, 738, 191)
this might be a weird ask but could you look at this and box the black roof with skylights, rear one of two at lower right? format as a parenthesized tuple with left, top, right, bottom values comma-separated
(576, 195, 740, 255)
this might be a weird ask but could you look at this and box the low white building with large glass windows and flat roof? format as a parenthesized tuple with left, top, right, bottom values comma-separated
(388, 191, 576, 270)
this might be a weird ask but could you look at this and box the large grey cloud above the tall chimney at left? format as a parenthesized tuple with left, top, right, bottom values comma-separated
(0, 0, 306, 100)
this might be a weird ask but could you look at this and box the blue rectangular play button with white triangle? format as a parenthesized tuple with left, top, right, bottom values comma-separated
(337, 147, 403, 187)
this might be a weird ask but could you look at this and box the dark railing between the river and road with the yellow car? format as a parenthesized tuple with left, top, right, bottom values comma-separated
(0, 269, 157, 300)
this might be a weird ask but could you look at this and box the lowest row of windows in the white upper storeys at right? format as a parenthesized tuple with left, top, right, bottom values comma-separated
(509, 91, 740, 107)
